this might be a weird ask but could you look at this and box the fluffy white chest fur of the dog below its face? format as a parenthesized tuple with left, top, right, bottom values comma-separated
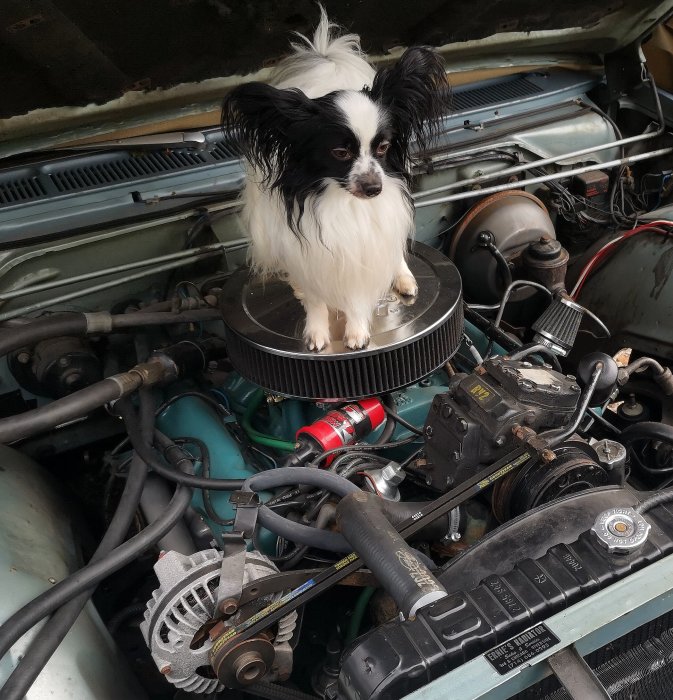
(244, 176, 413, 310)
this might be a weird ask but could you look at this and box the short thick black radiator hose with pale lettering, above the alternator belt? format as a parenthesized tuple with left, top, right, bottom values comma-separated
(337, 491, 447, 619)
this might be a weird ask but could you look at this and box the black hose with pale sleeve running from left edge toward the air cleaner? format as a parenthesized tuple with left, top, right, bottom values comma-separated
(0, 309, 221, 357)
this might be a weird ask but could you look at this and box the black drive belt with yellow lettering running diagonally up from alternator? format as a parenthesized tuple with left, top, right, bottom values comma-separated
(210, 448, 536, 657)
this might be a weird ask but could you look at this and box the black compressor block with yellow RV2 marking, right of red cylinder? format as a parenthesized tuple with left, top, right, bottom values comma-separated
(415, 357, 581, 491)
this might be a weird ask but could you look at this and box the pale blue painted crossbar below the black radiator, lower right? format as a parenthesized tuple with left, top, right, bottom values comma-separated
(406, 555, 673, 700)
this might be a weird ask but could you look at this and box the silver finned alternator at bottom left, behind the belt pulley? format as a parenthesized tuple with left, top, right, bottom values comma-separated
(140, 549, 297, 693)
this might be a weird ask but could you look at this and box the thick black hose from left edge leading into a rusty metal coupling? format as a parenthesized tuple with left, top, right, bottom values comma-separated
(0, 372, 142, 444)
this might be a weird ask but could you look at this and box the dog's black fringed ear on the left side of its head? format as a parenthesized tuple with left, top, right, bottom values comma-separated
(222, 83, 316, 185)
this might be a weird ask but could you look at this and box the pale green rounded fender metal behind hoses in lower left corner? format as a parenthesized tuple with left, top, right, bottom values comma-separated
(0, 446, 146, 700)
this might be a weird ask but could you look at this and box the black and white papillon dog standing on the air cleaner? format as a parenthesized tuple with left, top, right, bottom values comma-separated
(222, 8, 449, 351)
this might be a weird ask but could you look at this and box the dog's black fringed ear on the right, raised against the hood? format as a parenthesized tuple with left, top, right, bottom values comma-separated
(371, 47, 451, 151)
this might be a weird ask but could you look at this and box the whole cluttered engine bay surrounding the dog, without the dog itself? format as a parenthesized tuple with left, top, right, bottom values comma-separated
(0, 38, 673, 700)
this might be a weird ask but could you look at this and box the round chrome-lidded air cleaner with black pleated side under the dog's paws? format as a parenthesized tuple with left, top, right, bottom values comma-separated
(222, 243, 463, 400)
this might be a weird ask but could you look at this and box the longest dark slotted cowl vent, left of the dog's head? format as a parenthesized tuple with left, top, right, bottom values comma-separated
(49, 151, 208, 192)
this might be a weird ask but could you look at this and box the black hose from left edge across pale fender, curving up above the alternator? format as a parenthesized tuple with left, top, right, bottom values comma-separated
(0, 486, 192, 658)
